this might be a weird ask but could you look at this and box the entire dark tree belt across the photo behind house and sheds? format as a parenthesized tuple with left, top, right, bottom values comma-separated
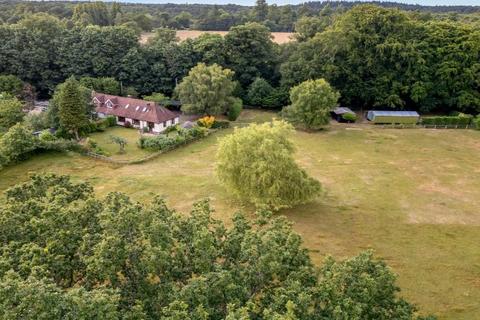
(0, 1, 480, 113)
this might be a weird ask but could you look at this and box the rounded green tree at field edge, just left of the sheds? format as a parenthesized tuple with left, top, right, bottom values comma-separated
(282, 79, 340, 129)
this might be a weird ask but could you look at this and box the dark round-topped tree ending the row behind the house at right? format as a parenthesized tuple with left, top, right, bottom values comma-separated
(225, 22, 278, 88)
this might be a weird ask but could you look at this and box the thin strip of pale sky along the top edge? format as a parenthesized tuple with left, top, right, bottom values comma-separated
(109, 0, 480, 6)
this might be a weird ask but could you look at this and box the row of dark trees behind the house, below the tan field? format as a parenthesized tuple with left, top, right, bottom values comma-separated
(0, 13, 279, 96)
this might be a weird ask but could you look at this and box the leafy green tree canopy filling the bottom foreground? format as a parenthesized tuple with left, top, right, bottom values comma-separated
(0, 174, 428, 320)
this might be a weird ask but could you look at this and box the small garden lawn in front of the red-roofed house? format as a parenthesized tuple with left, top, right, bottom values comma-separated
(90, 126, 155, 160)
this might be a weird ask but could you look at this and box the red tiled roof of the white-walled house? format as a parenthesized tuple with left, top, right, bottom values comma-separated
(92, 92, 178, 123)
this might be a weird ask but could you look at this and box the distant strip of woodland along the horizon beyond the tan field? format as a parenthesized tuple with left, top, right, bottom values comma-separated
(0, 0, 480, 31)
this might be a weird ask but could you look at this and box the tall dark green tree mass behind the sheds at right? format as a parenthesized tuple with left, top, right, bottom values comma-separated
(281, 5, 480, 112)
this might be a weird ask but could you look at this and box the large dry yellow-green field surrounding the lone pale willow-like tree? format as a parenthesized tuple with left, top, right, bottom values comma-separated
(0, 111, 480, 319)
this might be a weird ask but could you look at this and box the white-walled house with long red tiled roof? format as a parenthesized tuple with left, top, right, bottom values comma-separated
(92, 92, 179, 133)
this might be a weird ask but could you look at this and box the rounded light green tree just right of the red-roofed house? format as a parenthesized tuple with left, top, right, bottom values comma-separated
(175, 63, 235, 115)
